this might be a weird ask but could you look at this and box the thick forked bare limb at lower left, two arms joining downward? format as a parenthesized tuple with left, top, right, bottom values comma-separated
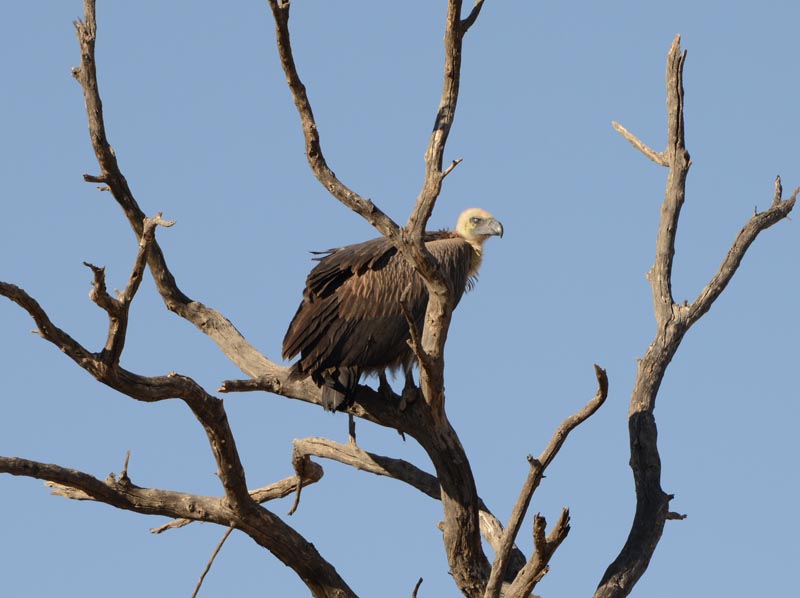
(0, 282, 355, 597)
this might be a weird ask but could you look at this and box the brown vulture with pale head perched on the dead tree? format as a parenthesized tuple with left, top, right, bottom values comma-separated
(283, 208, 503, 411)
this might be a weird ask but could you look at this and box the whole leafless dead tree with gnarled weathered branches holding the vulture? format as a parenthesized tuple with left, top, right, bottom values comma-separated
(0, 0, 797, 598)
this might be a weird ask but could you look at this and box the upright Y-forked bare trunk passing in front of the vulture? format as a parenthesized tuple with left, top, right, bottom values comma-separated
(269, 0, 489, 598)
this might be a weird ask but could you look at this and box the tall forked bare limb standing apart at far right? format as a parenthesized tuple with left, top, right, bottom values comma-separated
(595, 36, 797, 598)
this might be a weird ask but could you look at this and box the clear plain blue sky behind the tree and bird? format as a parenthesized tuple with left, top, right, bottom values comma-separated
(0, 0, 800, 598)
